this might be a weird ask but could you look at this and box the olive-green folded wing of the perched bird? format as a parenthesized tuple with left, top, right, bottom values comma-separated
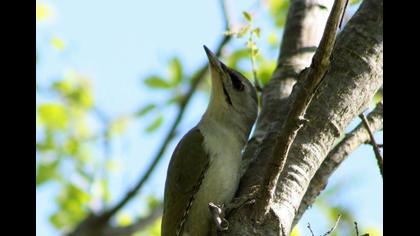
(162, 128, 209, 236)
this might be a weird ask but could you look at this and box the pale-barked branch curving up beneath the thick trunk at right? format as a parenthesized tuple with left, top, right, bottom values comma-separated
(293, 103, 383, 225)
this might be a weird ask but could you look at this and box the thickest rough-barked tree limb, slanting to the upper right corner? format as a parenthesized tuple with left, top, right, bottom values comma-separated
(226, 0, 383, 235)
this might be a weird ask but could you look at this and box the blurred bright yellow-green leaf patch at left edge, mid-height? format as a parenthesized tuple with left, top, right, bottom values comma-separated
(38, 103, 69, 129)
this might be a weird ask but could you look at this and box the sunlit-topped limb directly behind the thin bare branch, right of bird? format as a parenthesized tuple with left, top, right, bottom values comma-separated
(237, 0, 333, 199)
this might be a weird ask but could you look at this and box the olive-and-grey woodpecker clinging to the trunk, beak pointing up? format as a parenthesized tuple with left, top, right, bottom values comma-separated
(161, 45, 258, 236)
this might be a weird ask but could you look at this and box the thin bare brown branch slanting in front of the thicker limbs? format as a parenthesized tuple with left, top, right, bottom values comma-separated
(254, 0, 346, 220)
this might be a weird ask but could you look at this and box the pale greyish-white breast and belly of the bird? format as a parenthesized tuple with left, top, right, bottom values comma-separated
(183, 122, 242, 236)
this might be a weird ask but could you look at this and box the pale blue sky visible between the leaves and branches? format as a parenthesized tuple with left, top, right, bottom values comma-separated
(36, 0, 383, 236)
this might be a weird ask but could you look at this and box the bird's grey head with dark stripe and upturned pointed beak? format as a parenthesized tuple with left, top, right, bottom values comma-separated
(204, 46, 258, 137)
